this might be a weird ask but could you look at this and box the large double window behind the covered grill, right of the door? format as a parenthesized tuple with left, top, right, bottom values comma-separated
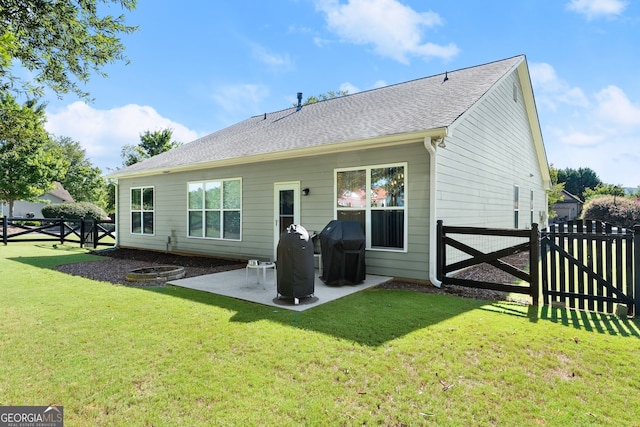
(335, 163, 407, 250)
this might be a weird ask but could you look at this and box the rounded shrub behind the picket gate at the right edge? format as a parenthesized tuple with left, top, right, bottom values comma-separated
(582, 196, 640, 228)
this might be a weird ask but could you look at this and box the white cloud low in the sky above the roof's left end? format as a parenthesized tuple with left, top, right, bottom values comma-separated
(45, 101, 201, 172)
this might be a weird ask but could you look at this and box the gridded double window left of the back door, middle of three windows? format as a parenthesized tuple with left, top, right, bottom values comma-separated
(187, 178, 242, 240)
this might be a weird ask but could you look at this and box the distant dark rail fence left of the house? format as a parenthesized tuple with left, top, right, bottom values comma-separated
(2, 216, 115, 248)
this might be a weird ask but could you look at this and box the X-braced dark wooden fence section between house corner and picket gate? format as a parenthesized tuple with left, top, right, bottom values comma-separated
(436, 220, 540, 305)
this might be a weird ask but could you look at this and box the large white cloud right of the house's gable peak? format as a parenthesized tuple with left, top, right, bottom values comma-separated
(530, 64, 640, 187)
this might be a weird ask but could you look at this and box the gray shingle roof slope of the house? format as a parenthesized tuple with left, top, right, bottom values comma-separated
(111, 56, 524, 176)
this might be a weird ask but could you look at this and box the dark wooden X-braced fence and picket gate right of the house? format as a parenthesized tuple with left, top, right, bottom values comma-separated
(437, 220, 640, 317)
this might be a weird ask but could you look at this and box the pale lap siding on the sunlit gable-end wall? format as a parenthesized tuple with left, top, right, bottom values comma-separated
(436, 73, 547, 228)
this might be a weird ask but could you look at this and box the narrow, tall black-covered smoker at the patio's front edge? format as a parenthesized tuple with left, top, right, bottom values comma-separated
(277, 224, 315, 304)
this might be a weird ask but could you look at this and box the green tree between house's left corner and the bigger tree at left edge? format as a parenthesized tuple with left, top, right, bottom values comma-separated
(53, 136, 107, 208)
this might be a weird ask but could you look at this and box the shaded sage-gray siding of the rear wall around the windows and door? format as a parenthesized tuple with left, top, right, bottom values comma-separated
(118, 141, 429, 280)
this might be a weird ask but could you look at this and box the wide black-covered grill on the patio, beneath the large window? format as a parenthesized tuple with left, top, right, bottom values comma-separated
(320, 220, 366, 286)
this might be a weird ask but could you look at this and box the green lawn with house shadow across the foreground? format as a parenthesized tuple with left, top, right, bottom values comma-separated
(0, 243, 640, 426)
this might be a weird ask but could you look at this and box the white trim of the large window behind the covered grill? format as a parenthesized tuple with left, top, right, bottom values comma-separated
(332, 162, 409, 253)
